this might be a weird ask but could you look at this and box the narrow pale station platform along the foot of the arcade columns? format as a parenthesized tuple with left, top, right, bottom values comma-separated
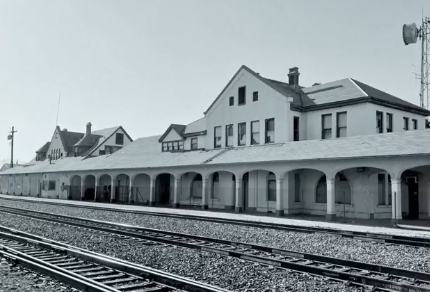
(0, 194, 430, 238)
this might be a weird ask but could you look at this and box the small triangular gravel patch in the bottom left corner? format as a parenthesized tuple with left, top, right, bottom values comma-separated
(0, 256, 80, 292)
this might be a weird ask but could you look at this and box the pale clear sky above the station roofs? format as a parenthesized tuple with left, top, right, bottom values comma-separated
(0, 0, 430, 163)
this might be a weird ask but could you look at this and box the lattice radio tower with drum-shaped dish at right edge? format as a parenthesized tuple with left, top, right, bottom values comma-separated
(403, 15, 430, 109)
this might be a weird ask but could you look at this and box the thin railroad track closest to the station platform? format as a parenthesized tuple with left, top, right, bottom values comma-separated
(0, 198, 430, 247)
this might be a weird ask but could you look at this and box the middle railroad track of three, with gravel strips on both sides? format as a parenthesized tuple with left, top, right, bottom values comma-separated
(0, 207, 430, 291)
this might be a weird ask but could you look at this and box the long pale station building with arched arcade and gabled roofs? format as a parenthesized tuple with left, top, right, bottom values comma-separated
(0, 66, 430, 220)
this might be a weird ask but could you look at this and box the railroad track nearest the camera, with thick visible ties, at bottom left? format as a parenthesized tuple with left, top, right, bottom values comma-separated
(0, 229, 232, 292)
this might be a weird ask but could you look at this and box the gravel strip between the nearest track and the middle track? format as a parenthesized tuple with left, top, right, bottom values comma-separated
(0, 213, 368, 291)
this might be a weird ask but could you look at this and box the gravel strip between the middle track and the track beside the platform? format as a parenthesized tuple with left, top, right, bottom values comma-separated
(0, 199, 430, 272)
